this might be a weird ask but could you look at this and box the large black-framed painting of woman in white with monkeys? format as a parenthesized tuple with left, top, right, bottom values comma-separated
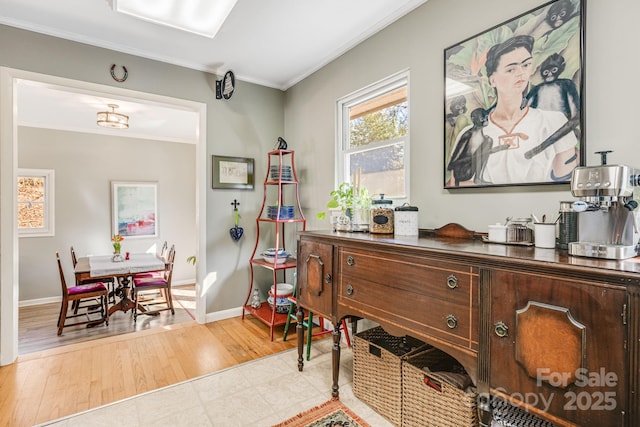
(444, 0, 584, 188)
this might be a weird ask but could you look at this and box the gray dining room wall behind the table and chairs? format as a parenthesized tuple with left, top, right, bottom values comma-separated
(18, 127, 196, 301)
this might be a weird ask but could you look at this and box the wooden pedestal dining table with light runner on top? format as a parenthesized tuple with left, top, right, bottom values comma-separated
(75, 252, 166, 316)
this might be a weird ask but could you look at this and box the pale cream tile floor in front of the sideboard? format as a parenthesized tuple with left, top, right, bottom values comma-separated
(41, 338, 391, 427)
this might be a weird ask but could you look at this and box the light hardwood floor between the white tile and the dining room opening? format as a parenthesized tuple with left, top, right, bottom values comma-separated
(0, 314, 296, 427)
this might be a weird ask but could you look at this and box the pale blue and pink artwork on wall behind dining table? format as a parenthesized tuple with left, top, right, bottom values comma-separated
(111, 181, 158, 238)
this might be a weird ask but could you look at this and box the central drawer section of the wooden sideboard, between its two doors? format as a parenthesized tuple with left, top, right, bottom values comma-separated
(337, 248, 479, 350)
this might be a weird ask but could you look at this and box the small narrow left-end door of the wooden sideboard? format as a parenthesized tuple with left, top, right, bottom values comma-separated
(298, 240, 333, 318)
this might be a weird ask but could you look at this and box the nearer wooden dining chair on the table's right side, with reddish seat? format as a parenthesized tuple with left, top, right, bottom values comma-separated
(132, 245, 176, 322)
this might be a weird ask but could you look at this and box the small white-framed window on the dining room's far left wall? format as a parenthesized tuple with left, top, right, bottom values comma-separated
(18, 169, 54, 237)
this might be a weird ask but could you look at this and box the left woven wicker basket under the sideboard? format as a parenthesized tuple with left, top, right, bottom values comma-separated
(353, 326, 429, 426)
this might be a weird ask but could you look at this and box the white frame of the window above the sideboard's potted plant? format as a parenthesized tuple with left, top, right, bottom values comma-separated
(334, 70, 411, 204)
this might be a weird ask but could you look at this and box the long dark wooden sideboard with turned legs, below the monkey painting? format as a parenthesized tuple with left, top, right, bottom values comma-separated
(297, 231, 640, 427)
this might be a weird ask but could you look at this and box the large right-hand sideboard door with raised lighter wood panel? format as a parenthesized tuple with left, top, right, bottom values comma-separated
(490, 270, 627, 426)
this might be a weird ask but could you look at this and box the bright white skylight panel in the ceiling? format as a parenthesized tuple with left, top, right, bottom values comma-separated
(113, 0, 237, 38)
